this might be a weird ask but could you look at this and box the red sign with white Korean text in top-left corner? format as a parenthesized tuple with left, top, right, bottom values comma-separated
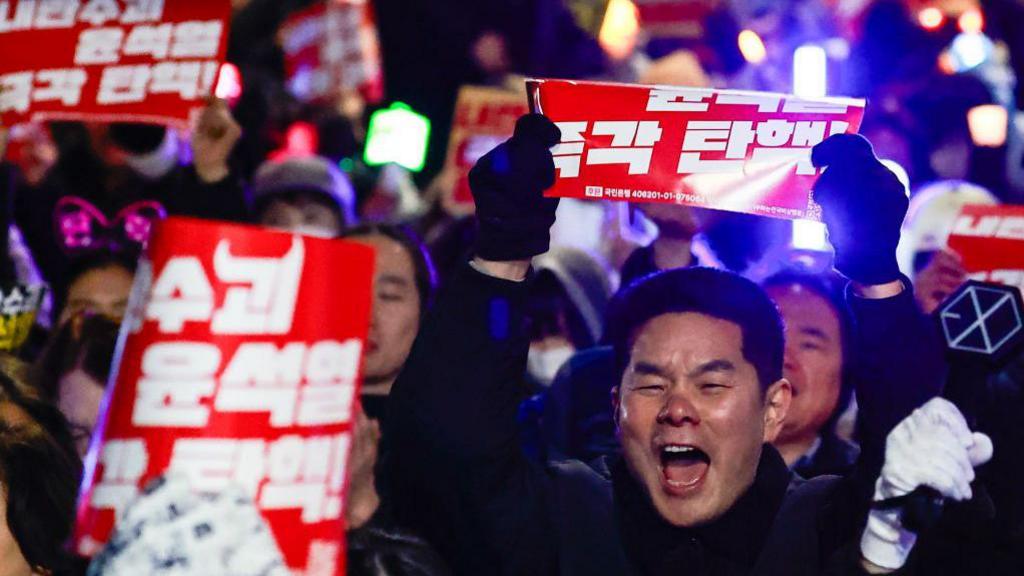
(0, 0, 231, 126)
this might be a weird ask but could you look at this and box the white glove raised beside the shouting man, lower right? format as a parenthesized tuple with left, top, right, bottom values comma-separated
(860, 398, 992, 570)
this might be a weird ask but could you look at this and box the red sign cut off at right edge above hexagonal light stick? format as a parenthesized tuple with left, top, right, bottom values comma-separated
(947, 205, 1024, 291)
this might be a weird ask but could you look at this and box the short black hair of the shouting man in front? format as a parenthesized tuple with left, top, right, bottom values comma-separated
(605, 268, 785, 390)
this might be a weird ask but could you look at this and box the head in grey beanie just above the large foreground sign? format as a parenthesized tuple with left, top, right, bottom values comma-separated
(252, 156, 355, 238)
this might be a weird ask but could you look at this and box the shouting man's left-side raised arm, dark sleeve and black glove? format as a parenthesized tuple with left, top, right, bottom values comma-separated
(384, 115, 559, 574)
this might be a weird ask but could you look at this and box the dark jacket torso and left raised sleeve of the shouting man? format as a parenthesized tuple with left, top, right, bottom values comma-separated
(382, 266, 983, 576)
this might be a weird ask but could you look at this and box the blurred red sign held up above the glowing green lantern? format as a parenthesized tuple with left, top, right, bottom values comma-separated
(279, 0, 384, 102)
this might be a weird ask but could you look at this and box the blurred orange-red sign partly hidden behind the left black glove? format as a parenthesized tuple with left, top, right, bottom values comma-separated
(444, 86, 529, 211)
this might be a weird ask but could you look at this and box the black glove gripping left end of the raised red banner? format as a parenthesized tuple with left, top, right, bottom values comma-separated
(469, 114, 561, 261)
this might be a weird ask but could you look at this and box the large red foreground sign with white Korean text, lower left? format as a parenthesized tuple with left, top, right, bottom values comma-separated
(75, 217, 374, 576)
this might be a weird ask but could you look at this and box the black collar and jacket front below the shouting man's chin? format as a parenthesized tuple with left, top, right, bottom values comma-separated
(611, 445, 792, 576)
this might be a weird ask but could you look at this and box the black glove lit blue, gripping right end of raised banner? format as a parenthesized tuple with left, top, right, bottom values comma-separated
(811, 130, 908, 285)
